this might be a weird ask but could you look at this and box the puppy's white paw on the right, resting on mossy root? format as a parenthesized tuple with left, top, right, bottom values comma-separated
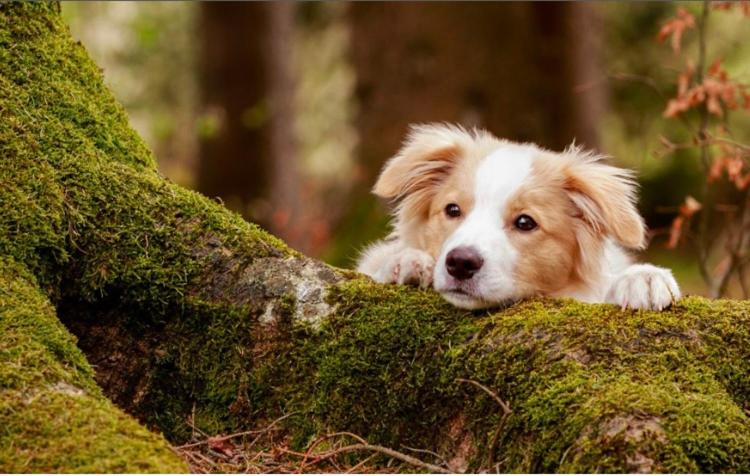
(606, 264, 680, 311)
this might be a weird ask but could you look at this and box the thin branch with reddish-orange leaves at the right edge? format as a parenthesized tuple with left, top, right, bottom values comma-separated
(656, 1, 750, 297)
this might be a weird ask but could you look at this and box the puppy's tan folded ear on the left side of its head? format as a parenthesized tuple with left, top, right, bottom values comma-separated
(372, 124, 469, 203)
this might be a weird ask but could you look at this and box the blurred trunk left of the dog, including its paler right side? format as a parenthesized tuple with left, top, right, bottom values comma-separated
(198, 2, 308, 251)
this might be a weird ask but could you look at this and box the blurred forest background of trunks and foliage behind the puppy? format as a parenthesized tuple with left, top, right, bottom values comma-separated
(62, 2, 750, 296)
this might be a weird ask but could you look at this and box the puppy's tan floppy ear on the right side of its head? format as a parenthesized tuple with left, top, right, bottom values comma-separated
(565, 148, 646, 249)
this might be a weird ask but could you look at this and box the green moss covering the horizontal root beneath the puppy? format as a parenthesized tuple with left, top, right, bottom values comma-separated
(255, 281, 750, 472)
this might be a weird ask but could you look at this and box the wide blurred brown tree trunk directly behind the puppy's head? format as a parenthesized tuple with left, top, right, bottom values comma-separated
(332, 2, 604, 266)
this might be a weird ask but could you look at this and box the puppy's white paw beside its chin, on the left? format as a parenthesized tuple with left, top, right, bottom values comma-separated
(357, 240, 435, 288)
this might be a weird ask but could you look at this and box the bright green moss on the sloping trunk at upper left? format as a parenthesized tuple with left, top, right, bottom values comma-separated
(0, 4, 289, 303)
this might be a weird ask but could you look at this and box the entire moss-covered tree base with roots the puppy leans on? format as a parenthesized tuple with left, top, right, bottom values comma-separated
(0, 3, 750, 472)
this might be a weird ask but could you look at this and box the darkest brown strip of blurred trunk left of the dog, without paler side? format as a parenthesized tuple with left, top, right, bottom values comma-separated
(198, 2, 272, 219)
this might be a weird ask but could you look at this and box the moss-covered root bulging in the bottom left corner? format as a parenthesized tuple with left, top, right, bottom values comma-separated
(0, 259, 186, 473)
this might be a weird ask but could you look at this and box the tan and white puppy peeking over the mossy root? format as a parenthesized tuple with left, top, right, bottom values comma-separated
(358, 125, 680, 310)
